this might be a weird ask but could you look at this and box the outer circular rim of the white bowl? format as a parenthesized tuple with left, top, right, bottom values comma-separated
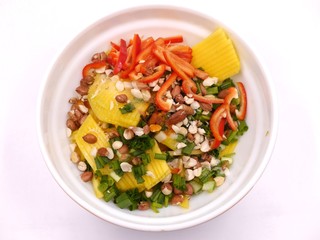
(36, 4, 279, 231)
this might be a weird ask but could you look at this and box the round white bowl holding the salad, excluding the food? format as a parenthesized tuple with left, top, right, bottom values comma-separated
(38, 6, 277, 231)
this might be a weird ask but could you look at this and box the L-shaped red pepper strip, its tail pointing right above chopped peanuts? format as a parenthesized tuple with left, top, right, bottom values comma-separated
(182, 79, 224, 104)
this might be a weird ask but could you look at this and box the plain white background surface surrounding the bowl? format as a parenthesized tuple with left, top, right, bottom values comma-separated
(0, 0, 320, 240)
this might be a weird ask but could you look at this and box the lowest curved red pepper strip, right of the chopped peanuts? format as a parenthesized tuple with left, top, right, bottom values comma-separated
(209, 104, 227, 142)
